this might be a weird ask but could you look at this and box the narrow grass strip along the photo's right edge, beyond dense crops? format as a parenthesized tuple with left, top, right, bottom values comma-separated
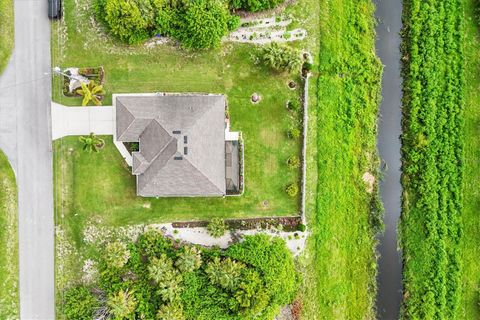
(457, 0, 480, 320)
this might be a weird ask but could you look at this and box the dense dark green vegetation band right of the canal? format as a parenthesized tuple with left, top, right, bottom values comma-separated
(401, 0, 465, 319)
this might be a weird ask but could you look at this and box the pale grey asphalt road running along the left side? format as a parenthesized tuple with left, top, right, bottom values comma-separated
(0, 0, 55, 320)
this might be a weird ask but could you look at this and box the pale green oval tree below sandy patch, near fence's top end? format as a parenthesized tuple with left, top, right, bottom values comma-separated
(260, 42, 302, 72)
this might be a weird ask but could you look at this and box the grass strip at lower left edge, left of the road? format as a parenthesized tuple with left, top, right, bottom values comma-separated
(0, 151, 19, 319)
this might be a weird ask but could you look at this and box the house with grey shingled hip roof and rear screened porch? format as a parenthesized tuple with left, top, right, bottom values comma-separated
(113, 94, 240, 197)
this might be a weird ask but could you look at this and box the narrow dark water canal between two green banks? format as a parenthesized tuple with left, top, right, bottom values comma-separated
(375, 0, 402, 320)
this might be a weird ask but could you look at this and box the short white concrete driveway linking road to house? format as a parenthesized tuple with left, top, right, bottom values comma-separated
(52, 102, 115, 140)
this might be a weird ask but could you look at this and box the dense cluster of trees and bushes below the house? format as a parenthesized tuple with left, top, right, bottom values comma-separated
(64, 230, 299, 320)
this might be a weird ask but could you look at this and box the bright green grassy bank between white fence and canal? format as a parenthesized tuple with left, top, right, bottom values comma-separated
(303, 0, 381, 320)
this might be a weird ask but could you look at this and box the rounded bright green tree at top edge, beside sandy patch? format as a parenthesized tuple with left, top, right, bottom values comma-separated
(174, 0, 235, 49)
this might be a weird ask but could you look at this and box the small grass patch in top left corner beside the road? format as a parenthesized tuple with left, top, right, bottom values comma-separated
(0, 0, 14, 74)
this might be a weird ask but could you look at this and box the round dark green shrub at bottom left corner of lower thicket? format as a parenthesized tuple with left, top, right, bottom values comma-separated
(63, 286, 99, 320)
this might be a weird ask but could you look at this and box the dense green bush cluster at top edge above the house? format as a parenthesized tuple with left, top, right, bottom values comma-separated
(95, 0, 240, 49)
